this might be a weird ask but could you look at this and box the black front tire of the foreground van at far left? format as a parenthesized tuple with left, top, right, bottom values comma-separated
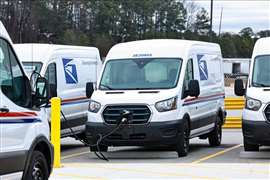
(25, 151, 49, 180)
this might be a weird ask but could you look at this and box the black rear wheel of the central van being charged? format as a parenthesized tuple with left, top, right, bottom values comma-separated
(208, 116, 222, 147)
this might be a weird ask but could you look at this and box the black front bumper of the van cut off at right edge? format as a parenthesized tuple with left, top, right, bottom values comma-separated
(242, 119, 270, 146)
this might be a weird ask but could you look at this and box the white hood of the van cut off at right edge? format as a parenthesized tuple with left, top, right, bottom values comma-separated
(247, 87, 270, 104)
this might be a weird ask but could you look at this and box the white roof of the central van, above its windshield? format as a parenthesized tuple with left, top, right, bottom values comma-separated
(106, 39, 220, 60)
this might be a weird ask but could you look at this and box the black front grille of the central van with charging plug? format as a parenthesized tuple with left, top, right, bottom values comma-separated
(103, 105, 151, 124)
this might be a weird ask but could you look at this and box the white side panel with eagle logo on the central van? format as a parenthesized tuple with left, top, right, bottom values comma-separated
(190, 47, 225, 135)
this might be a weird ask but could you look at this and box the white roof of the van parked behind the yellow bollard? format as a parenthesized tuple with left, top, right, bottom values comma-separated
(14, 43, 99, 63)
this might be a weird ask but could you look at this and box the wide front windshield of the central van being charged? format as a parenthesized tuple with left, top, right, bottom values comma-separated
(99, 58, 182, 90)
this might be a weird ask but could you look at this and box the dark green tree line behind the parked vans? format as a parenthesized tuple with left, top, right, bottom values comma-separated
(0, 0, 270, 58)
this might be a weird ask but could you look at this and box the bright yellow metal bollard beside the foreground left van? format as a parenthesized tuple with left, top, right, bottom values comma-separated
(51, 97, 61, 168)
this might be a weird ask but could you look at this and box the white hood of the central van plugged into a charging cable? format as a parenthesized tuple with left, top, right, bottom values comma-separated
(91, 89, 177, 106)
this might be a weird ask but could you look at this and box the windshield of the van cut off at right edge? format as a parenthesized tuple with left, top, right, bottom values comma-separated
(252, 55, 270, 87)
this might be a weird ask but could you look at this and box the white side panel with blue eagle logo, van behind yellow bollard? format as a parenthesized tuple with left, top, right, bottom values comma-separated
(45, 50, 100, 137)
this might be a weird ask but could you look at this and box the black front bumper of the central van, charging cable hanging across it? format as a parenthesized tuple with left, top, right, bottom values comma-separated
(86, 120, 183, 146)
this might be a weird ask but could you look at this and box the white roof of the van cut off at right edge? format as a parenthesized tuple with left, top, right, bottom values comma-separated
(252, 37, 270, 58)
